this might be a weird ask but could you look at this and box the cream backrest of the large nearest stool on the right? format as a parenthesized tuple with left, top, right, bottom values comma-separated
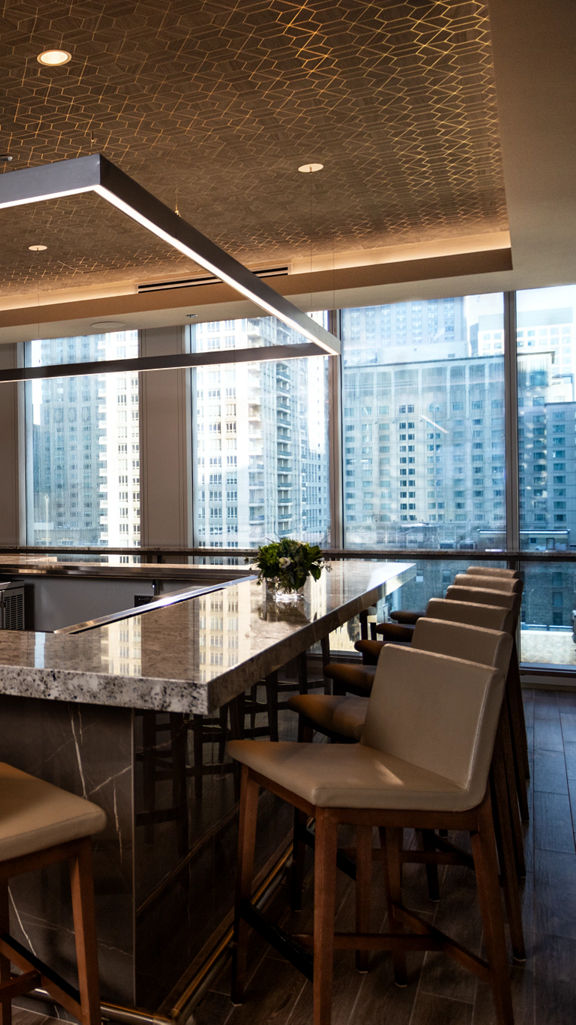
(361, 644, 504, 808)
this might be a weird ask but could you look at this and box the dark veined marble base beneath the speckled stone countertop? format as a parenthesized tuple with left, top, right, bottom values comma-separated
(0, 696, 295, 1014)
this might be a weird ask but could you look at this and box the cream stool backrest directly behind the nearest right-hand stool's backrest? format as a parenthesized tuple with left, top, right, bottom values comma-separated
(412, 616, 512, 672)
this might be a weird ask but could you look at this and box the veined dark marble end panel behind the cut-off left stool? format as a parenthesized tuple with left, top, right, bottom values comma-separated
(0, 696, 134, 1006)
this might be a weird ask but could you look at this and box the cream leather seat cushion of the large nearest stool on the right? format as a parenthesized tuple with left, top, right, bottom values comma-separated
(228, 740, 478, 812)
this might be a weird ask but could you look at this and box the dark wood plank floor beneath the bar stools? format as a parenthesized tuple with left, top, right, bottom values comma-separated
(14, 691, 576, 1025)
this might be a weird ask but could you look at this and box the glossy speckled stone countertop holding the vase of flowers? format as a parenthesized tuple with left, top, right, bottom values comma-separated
(0, 560, 414, 713)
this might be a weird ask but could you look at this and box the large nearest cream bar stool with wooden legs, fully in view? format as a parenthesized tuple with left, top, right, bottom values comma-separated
(229, 645, 513, 1025)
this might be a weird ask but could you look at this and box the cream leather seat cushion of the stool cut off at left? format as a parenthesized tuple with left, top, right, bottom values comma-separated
(0, 763, 106, 861)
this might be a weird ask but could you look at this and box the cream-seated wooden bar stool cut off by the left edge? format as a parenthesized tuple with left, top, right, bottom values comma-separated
(0, 763, 106, 1025)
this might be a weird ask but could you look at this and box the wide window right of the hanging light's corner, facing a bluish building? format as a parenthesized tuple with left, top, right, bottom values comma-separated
(342, 294, 506, 604)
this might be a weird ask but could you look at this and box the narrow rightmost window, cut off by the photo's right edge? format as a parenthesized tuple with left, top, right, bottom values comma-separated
(517, 285, 576, 664)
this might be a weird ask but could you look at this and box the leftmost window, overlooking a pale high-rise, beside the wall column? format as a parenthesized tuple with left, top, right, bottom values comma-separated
(25, 331, 140, 547)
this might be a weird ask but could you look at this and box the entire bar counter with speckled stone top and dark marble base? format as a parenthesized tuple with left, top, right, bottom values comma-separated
(0, 557, 415, 1018)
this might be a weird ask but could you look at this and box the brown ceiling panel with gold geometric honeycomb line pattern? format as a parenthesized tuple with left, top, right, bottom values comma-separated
(0, 0, 507, 295)
